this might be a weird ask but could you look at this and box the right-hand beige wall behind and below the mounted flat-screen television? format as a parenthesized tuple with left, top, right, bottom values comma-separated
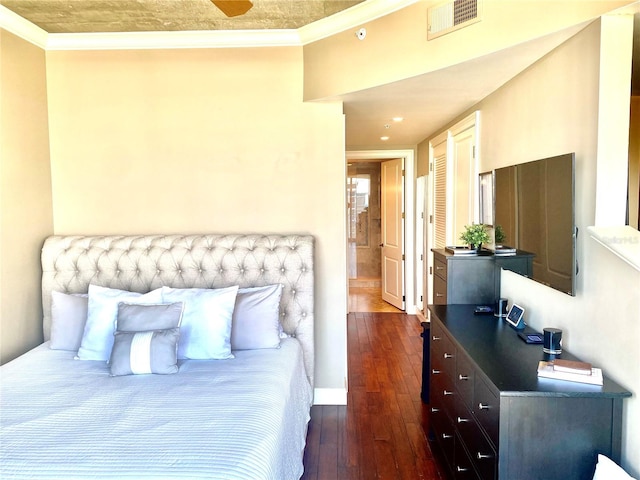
(422, 19, 640, 476)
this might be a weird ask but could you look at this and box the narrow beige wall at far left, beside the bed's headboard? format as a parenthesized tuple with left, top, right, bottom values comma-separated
(0, 29, 53, 363)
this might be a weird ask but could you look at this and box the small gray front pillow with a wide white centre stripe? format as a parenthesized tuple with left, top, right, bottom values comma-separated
(109, 327, 180, 377)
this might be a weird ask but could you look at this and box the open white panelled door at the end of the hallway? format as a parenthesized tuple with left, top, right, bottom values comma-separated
(380, 158, 405, 310)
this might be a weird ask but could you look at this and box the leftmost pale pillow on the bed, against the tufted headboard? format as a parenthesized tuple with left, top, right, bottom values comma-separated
(49, 291, 89, 352)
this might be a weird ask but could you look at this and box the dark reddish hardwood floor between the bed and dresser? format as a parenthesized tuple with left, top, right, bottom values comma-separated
(302, 313, 445, 480)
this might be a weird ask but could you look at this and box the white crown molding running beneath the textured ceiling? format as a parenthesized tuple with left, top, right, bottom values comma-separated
(0, 0, 419, 50)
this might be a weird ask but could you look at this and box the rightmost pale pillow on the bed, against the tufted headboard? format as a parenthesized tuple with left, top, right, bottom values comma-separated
(231, 284, 282, 350)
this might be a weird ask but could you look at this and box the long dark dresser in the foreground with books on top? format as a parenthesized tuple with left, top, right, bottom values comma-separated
(429, 305, 631, 480)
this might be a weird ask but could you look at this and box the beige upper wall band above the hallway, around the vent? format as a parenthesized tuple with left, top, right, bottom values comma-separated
(304, 0, 632, 101)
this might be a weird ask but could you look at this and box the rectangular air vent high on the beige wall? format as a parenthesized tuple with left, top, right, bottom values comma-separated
(427, 0, 482, 40)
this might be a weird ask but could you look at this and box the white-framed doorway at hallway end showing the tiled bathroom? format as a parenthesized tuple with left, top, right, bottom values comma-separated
(345, 150, 416, 314)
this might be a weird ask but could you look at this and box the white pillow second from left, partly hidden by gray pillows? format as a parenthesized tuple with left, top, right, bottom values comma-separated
(76, 285, 162, 361)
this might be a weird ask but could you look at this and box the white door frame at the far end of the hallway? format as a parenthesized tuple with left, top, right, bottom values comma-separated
(344, 149, 416, 315)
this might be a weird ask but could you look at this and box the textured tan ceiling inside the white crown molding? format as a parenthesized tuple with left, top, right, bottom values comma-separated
(0, 0, 363, 33)
